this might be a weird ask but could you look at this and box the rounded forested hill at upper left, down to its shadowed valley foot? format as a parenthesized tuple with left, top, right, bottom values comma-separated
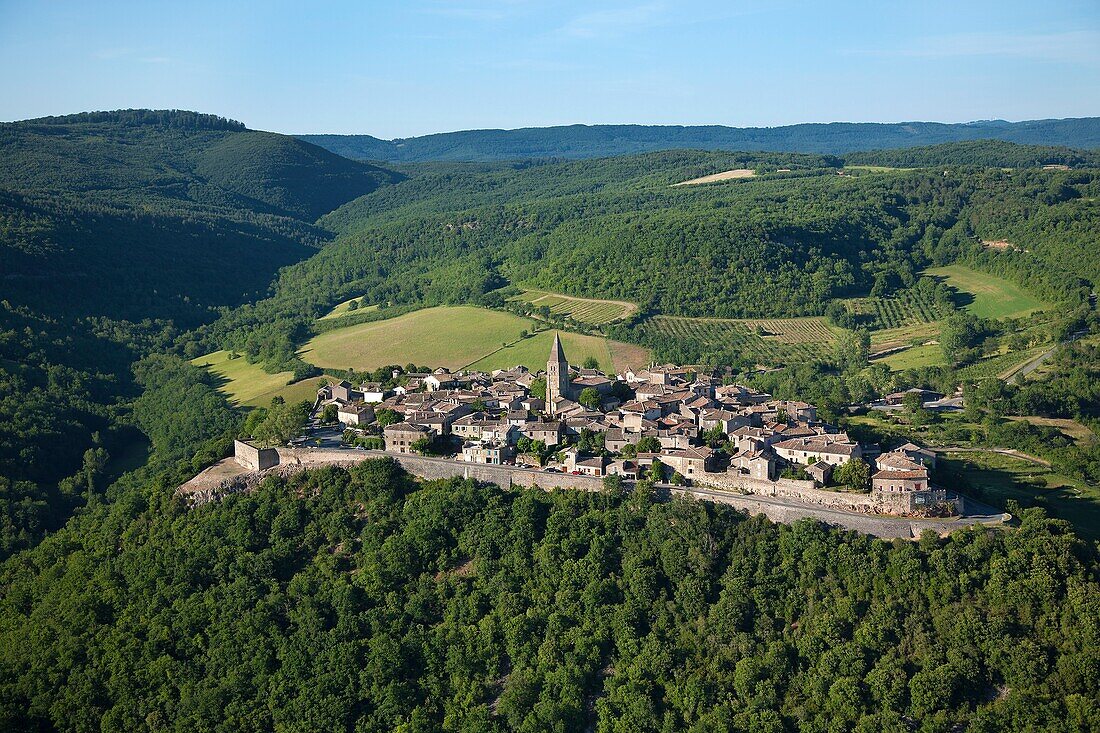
(0, 110, 400, 321)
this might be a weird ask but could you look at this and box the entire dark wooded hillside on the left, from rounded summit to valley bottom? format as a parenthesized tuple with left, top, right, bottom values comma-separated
(0, 110, 402, 557)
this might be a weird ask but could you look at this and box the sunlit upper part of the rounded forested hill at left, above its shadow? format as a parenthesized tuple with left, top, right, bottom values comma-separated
(0, 110, 397, 221)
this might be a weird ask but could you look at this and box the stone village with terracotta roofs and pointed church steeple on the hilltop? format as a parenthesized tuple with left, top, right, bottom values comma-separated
(266, 336, 957, 516)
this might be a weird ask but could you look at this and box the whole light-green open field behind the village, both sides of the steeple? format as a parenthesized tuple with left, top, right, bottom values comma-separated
(300, 306, 649, 370)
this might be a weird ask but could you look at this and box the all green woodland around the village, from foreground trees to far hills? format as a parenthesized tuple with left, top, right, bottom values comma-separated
(0, 110, 1100, 732)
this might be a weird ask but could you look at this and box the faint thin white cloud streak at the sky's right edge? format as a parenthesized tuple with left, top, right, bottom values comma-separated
(851, 31, 1100, 64)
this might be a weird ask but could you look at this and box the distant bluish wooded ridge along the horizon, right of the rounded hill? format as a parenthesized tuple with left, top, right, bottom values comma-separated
(298, 118, 1100, 162)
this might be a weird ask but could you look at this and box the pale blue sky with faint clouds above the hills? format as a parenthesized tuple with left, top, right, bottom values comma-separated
(0, 0, 1100, 139)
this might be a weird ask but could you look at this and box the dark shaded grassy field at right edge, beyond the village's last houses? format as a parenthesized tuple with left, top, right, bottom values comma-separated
(937, 452, 1100, 539)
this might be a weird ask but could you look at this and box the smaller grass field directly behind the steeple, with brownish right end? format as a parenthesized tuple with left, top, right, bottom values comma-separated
(471, 331, 649, 373)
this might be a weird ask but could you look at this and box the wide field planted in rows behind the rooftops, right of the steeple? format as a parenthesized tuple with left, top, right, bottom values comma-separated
(647, 316, 837, 365)
